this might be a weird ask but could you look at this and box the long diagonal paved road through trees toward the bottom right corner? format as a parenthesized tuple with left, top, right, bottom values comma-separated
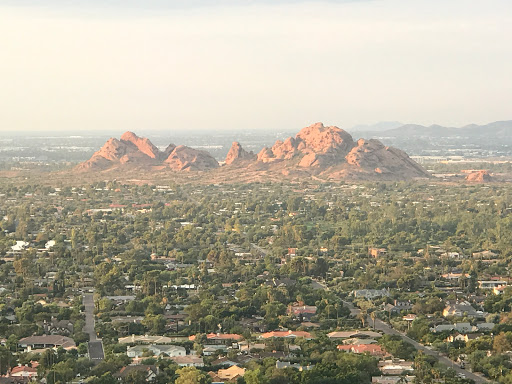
(343, 301, 492, 384)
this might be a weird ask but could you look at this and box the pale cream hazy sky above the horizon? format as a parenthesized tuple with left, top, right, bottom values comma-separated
(0, 0, 512, 132)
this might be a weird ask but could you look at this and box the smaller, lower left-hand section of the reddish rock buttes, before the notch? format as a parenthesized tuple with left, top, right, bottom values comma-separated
(76, 132, 218, 171)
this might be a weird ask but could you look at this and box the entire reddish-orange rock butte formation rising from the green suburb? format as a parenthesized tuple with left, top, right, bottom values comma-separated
(75, 123, 429, 181)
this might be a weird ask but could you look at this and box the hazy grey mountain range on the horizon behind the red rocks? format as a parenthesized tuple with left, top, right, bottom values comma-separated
(356, 120, 512, 140)
